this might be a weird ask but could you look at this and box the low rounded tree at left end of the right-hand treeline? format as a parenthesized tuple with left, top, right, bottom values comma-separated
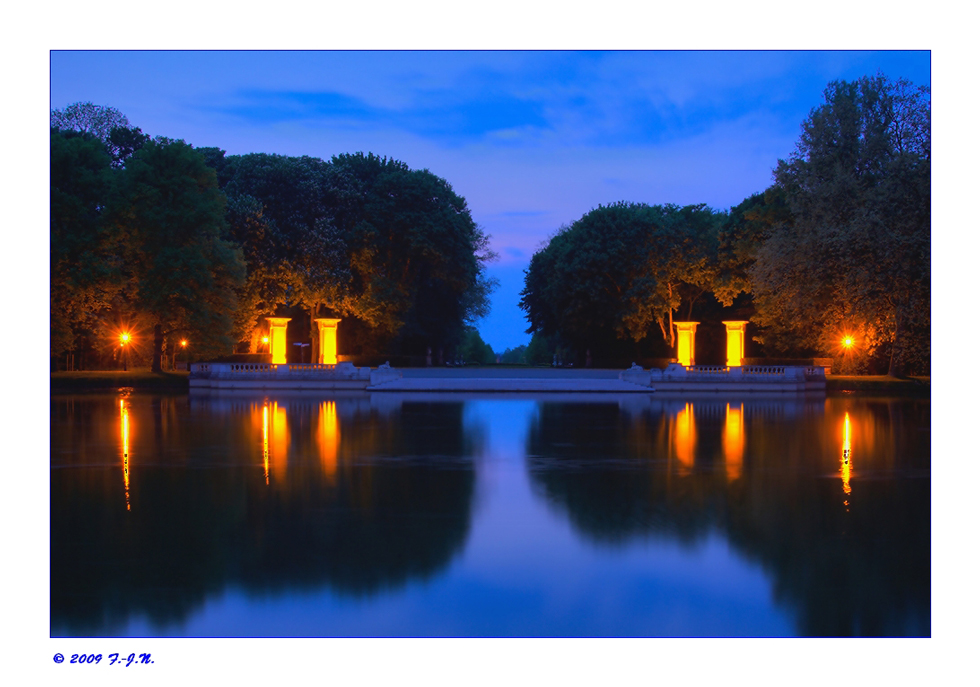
(520, 203, 724, 360)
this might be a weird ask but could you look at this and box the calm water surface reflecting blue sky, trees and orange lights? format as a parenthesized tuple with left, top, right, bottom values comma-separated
(51, 390, 930, 637)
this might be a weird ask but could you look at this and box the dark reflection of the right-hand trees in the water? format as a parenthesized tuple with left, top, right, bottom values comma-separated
(528, 399, 930, 636)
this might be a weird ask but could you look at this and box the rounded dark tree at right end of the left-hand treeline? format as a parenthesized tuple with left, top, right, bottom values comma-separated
(331, 153, 496, 353)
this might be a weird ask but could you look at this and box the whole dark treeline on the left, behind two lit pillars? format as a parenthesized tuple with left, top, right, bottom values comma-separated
(51, 103, 494, 370)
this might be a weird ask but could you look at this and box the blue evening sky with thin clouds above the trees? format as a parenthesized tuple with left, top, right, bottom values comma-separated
(51, 51, 931, 352)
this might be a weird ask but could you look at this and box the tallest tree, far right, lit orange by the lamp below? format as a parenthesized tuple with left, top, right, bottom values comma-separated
(750, 75, 931, 375)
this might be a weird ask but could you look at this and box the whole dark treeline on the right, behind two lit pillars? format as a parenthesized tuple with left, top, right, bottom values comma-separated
(520, 75, 931, 375)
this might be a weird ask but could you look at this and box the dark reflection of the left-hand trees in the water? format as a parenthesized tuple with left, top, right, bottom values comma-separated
(51, 397, 475, 634)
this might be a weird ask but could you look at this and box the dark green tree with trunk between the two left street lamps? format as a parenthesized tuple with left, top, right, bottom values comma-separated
(112, 139, 245, 372)
